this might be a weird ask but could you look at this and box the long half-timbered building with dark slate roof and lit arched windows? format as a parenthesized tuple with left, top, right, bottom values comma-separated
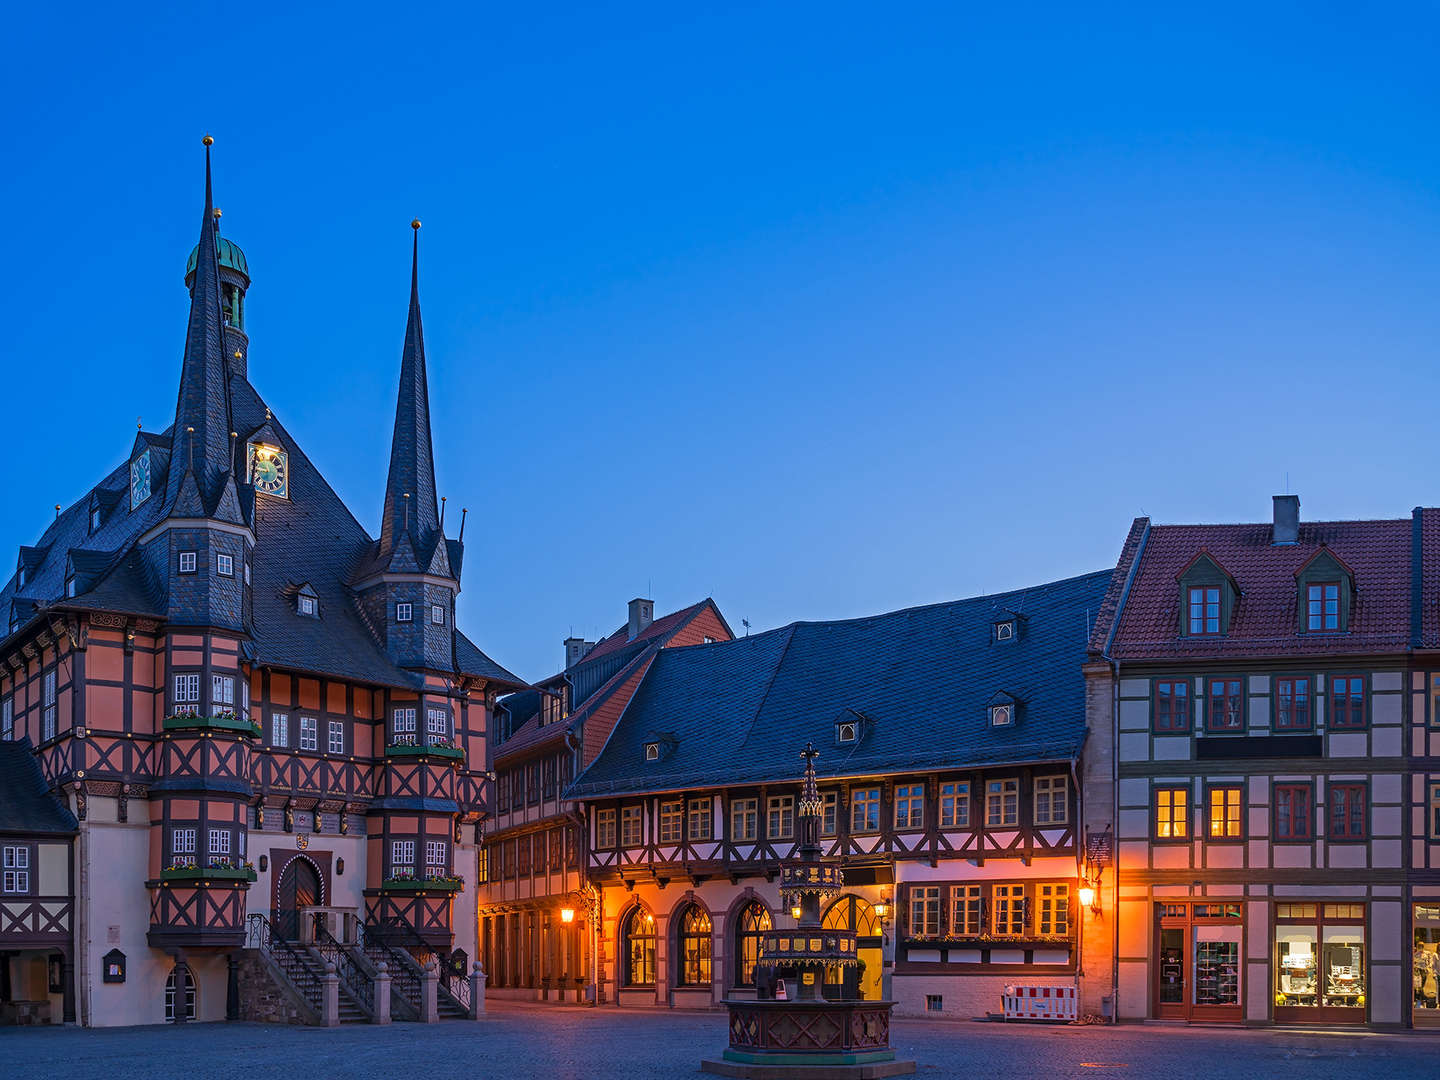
(555, 572, 1110, 1017)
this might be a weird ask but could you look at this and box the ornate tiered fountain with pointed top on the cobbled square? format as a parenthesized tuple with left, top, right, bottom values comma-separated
(700, 743, 914, 1080)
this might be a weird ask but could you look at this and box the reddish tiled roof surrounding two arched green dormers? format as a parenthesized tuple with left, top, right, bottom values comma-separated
(1092, 511, 1411, 661)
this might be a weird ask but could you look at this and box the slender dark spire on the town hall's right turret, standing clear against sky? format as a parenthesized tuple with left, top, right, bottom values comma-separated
(380, 219, 439, 562)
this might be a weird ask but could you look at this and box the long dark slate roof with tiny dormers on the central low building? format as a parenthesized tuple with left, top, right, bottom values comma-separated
(566, 570, 1112, 798)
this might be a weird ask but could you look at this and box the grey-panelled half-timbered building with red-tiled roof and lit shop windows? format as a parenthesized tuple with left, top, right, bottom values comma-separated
(1087, 495, 1416, 1027)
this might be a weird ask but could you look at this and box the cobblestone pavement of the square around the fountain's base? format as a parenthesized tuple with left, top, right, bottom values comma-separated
(0, 1004, 1440, 1080)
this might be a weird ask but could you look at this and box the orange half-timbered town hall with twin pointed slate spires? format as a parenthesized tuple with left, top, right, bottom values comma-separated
(0, 140, 521, 1025)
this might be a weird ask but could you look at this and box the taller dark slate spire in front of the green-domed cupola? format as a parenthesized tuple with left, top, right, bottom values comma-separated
(166, 135, 232, 518)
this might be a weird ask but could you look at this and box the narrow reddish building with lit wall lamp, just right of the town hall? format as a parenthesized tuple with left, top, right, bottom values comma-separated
(480, 598, 733, 1002)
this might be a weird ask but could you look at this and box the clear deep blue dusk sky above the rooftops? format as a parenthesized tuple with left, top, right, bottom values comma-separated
(0, 3, 1440, 678)
